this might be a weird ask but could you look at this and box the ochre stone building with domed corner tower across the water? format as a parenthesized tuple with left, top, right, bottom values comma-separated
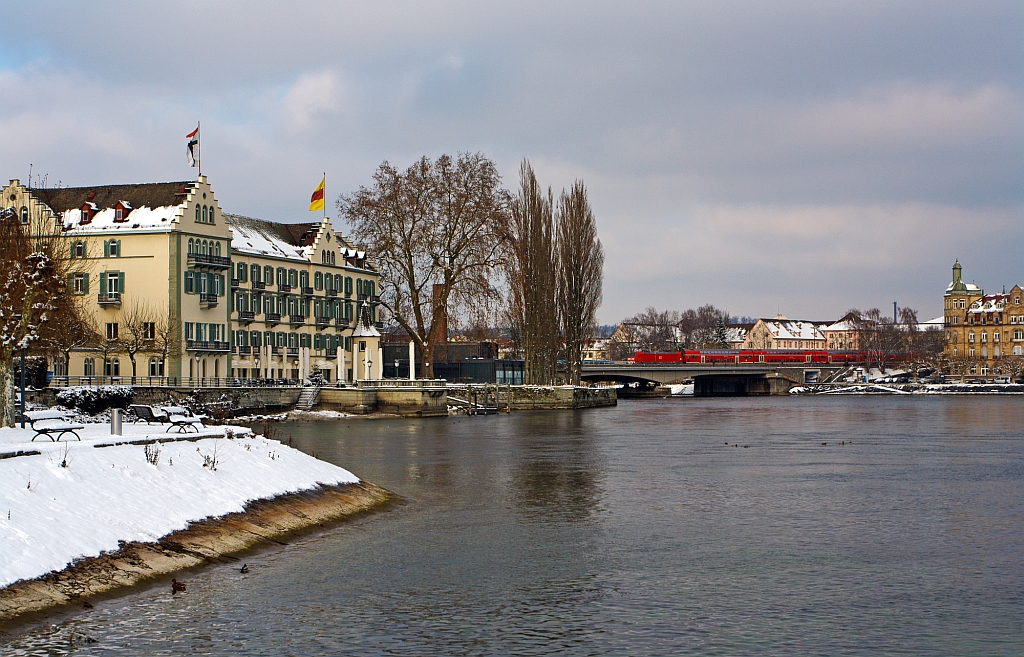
(943, 260, 1024, 376)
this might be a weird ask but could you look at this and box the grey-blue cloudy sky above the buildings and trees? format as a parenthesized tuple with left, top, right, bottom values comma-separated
(0, 0, 1024, 322)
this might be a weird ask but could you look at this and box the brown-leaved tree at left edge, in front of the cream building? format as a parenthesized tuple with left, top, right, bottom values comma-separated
(0, 209, 76, 427)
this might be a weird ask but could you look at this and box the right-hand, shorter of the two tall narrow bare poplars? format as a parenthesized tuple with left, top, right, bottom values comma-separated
(555, 180, 604, 386)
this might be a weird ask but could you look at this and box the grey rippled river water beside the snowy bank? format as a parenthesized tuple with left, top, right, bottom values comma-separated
(0, 396, 1024, 655)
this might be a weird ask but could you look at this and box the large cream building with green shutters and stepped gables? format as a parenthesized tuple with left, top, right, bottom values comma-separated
(2, 176, 380, 385)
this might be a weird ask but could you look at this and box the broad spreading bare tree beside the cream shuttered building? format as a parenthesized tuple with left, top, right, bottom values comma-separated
(337, 154, 507, 378)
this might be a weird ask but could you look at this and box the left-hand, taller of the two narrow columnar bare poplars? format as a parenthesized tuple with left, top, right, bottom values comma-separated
(506, 160, 558, 385)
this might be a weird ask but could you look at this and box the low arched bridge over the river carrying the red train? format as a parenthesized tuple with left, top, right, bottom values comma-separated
(581, 362, 847, 397)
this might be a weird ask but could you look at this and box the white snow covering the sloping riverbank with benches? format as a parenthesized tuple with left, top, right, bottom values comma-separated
(0, 425, 358, 586)
